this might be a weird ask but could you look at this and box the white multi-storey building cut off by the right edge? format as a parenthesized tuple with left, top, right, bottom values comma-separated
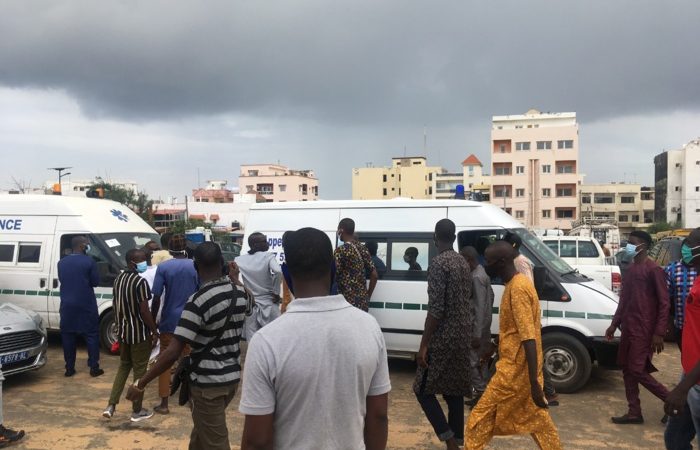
(654, 138, 700, 228)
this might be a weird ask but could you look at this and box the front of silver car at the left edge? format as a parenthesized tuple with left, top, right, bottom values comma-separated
(0, 303, 48, 376)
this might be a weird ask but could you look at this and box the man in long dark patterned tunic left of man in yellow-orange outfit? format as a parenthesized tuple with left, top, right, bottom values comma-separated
(413, 219, 471, 450)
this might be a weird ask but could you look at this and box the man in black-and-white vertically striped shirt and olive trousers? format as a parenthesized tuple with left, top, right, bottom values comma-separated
(102, 249, 158, 422)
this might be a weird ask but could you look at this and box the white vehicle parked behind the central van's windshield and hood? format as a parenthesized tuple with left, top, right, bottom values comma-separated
(540, 236, 622, 294)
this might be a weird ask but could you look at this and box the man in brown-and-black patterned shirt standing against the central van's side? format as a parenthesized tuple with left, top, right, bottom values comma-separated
(333, 218, 378, 311)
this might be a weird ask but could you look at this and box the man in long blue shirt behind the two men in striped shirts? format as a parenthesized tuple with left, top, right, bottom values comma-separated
(151, 234, 199, 414)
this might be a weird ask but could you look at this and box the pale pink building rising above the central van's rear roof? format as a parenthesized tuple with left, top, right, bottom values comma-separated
(238, 164, 318, 202)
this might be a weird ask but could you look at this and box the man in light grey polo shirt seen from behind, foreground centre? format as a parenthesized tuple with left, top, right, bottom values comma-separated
(240, 228, 391, 450)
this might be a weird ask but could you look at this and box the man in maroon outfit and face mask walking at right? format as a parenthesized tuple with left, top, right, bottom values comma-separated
(605, 231, 670, 425)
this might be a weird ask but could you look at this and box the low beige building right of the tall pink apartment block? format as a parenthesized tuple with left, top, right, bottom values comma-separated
(579, 182, 654, 236)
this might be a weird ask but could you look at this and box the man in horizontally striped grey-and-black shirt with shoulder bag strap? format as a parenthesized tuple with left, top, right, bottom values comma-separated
(127, 242, 248, 450)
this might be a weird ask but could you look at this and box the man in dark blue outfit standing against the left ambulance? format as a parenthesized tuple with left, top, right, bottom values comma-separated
(58, 236, 104, 377)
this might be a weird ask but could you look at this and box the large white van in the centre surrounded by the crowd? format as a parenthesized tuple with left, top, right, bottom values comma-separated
(243, 199, 617, 392)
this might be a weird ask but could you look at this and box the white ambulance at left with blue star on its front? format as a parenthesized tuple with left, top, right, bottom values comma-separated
(0, 195, 159, 348)
